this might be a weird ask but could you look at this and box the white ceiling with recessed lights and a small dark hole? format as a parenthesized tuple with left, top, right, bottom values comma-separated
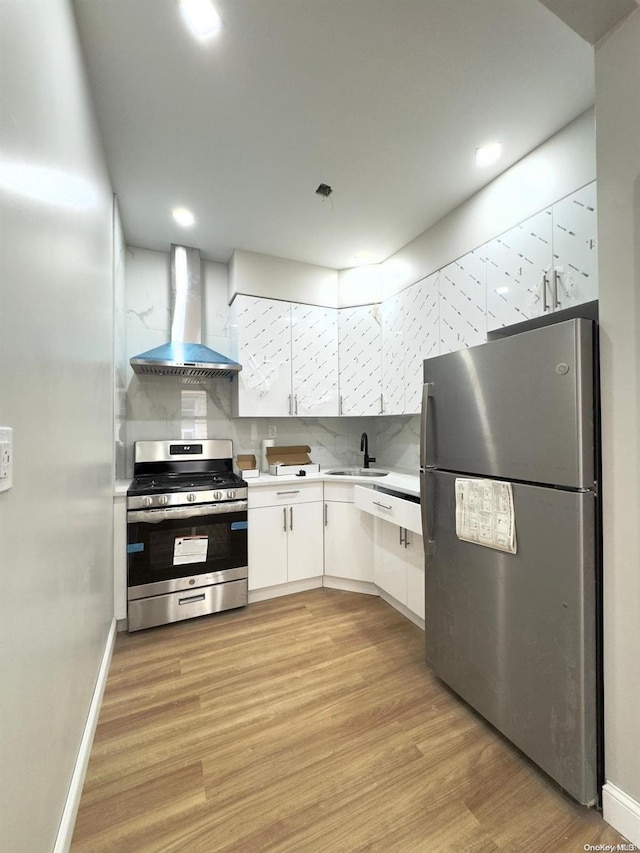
(74, 0, 594, 269)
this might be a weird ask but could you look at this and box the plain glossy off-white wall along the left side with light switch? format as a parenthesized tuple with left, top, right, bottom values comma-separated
(0, 0, 113, 853)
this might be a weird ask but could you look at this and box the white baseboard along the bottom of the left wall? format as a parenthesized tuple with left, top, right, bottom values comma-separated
(53, 616, 116, 853)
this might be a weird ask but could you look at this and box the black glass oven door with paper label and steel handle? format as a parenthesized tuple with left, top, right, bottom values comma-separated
(127, 501, 247, 592)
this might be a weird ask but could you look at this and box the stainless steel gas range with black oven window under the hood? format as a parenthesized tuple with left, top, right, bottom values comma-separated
(127, 439, 248, 631)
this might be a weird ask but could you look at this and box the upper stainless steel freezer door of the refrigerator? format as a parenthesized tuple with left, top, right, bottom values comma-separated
(422, 320, 595, 489)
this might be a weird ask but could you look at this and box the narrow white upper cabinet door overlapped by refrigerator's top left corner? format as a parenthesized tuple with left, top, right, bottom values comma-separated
(403, 273, 440, 415)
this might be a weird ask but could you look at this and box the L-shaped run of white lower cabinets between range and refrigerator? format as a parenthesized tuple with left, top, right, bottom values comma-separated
(248, 482, 424, 619)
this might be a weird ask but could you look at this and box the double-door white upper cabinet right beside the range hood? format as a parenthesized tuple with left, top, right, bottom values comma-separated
(231, 295, 338, 417)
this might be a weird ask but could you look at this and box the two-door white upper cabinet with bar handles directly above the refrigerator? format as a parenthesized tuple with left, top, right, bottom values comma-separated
(487, 182, 598, 330)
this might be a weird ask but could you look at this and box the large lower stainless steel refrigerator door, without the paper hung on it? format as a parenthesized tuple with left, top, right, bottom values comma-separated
(422, 471, 598, 805)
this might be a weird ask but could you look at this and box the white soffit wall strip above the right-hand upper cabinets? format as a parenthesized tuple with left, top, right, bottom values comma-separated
(338, 110, 596, 306)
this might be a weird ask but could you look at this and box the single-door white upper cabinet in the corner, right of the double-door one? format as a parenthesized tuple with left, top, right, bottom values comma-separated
(338, 305, 382, 416)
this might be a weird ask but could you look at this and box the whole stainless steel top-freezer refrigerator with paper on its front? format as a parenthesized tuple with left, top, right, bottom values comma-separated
(420, 320, 601, 805)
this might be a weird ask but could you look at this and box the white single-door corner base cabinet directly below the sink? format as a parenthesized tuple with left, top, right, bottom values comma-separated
(324, 483, 373, 583)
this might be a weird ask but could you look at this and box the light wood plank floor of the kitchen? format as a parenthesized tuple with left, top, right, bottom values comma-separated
(71, 589, 623, 853)
